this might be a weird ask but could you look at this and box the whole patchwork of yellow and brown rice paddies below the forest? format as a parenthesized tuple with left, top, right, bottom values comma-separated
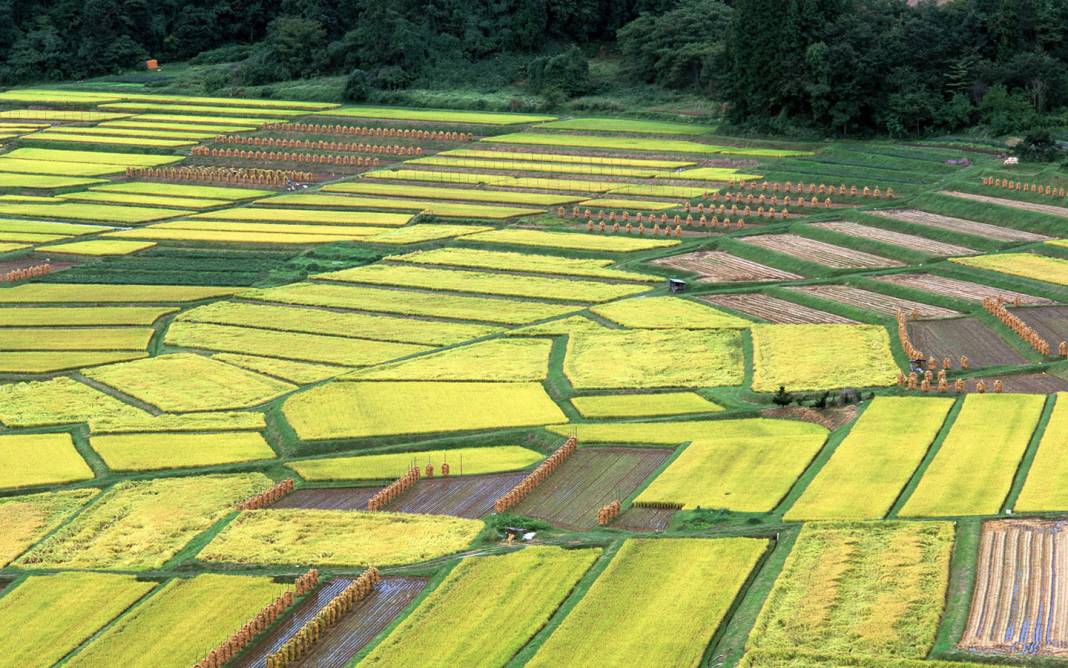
(6, 89, 1068, 668)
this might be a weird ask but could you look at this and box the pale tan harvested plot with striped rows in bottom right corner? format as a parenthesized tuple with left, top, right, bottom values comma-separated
(960, 519, 1068, 656)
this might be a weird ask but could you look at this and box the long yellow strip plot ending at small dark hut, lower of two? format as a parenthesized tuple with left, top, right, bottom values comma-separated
(313, 264, 648, 302)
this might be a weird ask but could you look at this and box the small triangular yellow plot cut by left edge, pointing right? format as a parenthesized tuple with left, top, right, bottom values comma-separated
(0, 488, 99, 568)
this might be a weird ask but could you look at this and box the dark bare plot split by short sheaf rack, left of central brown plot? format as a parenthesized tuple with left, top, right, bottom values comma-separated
(273, 473, 527, 519)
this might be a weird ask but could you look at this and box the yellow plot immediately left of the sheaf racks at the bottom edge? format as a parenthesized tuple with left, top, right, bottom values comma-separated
(66, 574, 288, 668)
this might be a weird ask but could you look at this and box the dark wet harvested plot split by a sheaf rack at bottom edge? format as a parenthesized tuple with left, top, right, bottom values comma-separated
(234, 577, 426, 668)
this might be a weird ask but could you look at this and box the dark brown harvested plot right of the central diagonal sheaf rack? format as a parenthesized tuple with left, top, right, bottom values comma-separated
(515, 448, 672, 530)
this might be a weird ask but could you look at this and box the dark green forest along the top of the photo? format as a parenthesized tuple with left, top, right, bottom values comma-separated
(0, 0, 1068, 137)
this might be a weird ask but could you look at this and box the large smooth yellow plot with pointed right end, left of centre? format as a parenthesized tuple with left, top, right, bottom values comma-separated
(283, 380, 567, 440)
